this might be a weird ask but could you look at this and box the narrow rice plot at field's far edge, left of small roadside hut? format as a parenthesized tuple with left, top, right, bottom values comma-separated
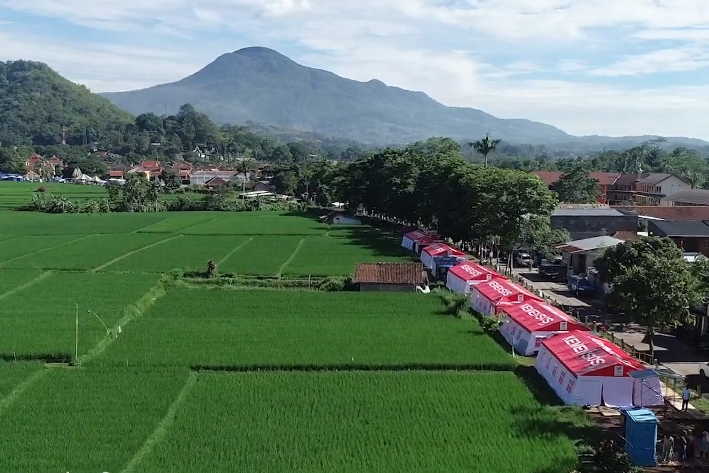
(184, 212, 327, 236)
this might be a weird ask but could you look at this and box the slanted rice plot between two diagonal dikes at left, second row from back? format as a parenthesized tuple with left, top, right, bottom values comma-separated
(5, 233, 169, 270)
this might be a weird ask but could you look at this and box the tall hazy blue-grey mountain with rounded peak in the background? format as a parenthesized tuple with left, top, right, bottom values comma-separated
(102, 47, 573, 144)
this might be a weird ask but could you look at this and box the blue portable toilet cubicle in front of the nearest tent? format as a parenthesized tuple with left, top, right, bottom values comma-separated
(621, 409, 659, 466)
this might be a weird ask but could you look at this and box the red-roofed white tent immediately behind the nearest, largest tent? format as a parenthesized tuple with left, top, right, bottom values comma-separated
(500, 300, 591, 356)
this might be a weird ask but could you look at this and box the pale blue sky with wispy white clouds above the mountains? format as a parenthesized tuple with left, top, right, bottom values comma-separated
(0, 0, 709, 140)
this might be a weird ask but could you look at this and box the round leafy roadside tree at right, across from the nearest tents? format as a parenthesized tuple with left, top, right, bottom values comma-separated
(596, 237, 704, 355)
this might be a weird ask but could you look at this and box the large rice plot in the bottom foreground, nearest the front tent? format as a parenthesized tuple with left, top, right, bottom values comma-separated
(136, 372, 576, 473)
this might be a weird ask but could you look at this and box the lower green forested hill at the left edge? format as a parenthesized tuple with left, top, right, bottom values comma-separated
(0, 61, 133, 145)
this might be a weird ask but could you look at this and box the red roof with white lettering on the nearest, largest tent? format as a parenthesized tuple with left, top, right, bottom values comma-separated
(542, 331, 645, 377)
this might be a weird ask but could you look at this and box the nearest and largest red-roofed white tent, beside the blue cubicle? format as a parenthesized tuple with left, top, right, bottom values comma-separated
(535, 331, 664, 407)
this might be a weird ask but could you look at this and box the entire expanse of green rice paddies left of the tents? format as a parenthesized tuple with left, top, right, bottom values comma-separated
(0, 211, 590, 473)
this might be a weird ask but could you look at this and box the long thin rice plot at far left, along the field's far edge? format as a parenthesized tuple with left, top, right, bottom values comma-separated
(0, 212, 165, 236)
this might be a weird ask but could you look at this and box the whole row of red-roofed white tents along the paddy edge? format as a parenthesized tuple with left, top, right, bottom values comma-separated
(402, 227, 664, 407)
